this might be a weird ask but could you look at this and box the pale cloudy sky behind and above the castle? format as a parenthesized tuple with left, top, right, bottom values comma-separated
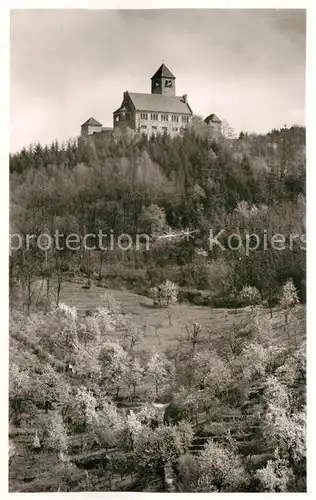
(11, 9, 305, 151)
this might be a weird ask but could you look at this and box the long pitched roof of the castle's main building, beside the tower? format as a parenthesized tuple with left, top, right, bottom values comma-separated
(128, 92, 192, 114)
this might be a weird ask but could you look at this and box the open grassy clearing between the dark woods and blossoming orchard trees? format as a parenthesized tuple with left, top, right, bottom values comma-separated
(61, 282, 305, 351)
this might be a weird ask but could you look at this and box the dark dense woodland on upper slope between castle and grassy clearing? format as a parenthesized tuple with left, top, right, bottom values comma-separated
(10, 124, 305, 305)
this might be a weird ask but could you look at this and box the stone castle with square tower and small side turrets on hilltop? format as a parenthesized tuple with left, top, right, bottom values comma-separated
(81, 64, 222, 140)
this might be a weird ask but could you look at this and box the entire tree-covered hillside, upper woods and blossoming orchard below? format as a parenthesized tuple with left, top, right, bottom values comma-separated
(9, 119, 306, 492)
